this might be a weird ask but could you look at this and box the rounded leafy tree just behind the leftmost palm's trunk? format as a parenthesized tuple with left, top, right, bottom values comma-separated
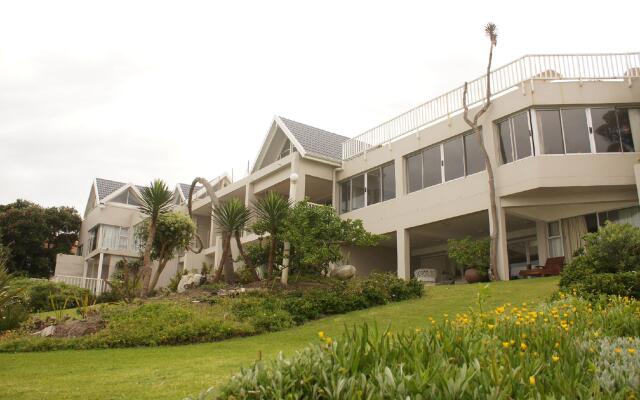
(136, 212, 196, 290)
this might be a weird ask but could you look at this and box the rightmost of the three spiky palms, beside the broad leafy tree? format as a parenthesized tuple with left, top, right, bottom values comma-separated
(253, 192, 291, 275)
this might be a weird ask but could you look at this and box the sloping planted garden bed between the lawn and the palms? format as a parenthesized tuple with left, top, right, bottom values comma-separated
(0, 274, 423, 352)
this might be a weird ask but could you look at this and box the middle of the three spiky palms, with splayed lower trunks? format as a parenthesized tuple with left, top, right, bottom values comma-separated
(213, 198, 258, 282)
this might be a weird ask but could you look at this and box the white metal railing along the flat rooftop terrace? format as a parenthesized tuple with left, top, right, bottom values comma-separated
(342, 53, 640, 160)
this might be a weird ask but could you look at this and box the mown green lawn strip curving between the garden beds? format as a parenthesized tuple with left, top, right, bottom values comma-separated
(0, 278, 558, 400)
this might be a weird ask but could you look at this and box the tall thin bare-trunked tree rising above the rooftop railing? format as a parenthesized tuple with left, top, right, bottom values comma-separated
(462, 22, 500, 280)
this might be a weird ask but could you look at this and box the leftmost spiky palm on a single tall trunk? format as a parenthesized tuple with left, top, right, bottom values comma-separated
(139, 179, 173, 296)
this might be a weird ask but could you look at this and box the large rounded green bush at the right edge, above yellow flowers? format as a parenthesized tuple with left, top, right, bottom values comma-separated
(560, 222, 640, 297)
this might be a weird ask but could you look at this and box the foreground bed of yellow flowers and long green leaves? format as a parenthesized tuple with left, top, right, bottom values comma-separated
(210, 296, 640, 400)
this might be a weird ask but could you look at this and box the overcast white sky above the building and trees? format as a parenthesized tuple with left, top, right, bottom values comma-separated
(0, 0, 640, 213)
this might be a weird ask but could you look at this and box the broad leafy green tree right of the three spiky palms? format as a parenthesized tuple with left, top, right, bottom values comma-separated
(281, 200, 385, 270)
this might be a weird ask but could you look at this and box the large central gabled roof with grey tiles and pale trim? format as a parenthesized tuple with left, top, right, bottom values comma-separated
(253, 116, 349, 171)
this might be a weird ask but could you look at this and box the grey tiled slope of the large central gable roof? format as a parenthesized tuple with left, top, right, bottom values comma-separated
(280, 117, 349, 161)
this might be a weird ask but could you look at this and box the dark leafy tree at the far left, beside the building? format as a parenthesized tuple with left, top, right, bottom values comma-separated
(0, 200, 82, 277)
